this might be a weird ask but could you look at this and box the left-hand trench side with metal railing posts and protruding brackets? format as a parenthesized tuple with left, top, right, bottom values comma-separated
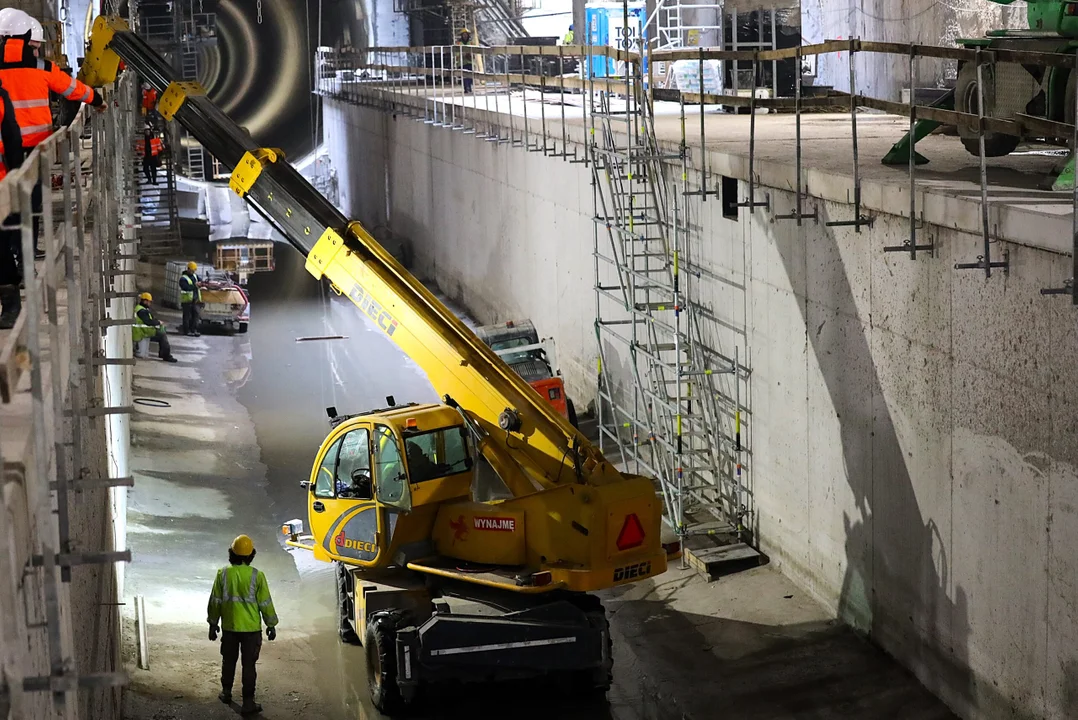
(0, 73, 138, 718)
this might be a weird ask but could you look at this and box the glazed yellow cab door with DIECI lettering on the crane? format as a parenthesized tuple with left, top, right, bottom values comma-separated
(307, 424, 384, 566)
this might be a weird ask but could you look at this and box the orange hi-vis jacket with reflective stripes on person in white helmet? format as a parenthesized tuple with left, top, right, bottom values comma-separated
(0, 36, 101, 149)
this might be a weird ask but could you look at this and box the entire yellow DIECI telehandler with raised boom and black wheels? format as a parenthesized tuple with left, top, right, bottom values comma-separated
(80, 16, 679, 711)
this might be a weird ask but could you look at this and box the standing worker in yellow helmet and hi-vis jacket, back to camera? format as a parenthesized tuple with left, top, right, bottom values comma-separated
(206, 535, 277, 715)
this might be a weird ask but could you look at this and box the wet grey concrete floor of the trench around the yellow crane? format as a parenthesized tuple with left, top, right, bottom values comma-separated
(125, 245, 952, 720)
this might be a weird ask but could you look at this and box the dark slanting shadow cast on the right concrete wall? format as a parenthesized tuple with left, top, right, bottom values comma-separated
(770, 199, 977, 712)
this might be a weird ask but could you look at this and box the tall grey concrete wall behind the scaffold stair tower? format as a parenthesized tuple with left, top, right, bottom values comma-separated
(326, 100, 1078, 719)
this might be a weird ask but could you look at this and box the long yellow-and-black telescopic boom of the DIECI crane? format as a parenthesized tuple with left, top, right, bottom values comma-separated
(86, 16, 623, 496)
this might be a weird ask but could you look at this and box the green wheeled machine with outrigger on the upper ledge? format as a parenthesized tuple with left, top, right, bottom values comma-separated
(883, 0, 1078, 189)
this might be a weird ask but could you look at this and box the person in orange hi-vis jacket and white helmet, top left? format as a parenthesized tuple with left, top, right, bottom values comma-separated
(0, 8, 105, 264)
